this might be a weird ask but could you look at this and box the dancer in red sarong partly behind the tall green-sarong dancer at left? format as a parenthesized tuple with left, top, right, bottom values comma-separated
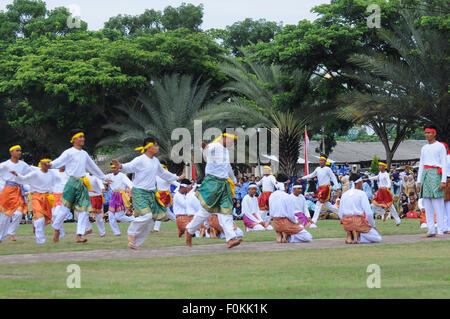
(84, 173, 106, 238)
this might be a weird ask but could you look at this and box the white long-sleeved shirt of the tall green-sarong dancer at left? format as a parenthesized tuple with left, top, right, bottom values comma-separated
(50, 147, 105, 180)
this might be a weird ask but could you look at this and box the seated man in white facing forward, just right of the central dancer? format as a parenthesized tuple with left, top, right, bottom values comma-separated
(241, 185, 273, 231)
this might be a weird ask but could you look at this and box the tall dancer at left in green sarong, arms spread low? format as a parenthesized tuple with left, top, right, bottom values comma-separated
(43, 129, 105, 243)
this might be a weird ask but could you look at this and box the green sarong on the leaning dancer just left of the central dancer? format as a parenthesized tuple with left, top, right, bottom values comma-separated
(131, 187, 166, 220)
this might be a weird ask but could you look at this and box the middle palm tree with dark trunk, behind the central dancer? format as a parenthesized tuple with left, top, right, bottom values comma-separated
(197, 58, 306, 176)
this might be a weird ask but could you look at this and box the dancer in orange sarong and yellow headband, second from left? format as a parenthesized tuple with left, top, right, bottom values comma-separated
(11, 158, 56, 244)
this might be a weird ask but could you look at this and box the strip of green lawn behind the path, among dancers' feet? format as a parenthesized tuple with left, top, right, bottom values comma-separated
(0, 219, 426, 255)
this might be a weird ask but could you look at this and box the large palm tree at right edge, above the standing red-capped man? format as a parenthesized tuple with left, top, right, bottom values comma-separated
(340, 4, 450, 166)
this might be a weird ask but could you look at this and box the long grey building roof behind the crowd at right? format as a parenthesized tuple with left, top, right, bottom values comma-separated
(299, 140, 427, 164)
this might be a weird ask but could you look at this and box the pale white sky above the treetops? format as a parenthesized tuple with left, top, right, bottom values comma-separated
(0, 0, 330, 30)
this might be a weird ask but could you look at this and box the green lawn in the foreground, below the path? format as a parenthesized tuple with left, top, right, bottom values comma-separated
(0, 242, 450, 299)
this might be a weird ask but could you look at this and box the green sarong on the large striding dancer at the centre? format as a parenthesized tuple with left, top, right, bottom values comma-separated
(195, 175, 233, 215)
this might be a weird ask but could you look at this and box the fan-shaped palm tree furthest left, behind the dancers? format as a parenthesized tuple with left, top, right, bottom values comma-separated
(98, 74, 213, 172)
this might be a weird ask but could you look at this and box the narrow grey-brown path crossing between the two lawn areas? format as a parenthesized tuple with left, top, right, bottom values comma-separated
(0, 234, 450, 264)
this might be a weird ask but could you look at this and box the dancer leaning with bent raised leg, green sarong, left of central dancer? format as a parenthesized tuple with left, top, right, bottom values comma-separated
(112, 137, 184, 250)
